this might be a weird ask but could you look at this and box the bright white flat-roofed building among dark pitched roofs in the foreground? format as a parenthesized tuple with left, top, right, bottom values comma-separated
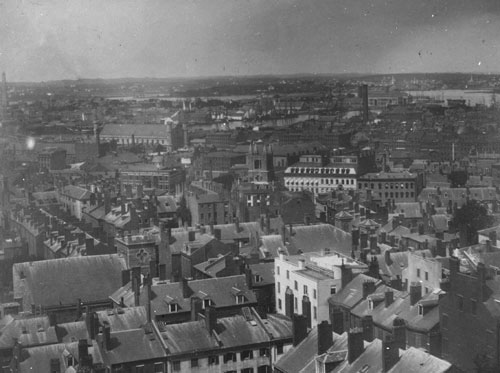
(274, 251, 366, 328)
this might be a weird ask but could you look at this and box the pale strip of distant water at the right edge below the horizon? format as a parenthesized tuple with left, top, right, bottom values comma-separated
(407, 89, 500, 106)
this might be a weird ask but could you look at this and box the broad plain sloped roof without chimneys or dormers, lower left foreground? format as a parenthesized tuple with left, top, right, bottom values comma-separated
(13, 254, 126, 306)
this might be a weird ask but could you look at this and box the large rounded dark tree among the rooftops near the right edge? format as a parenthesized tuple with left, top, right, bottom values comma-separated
(451, 200, 494, 246)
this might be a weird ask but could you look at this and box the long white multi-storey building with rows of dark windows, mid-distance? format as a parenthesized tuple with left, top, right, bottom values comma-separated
(284, 155, 358, 195)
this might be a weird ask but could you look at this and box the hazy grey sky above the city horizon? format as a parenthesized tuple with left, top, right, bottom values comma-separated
(0, 0, 500, 81)
